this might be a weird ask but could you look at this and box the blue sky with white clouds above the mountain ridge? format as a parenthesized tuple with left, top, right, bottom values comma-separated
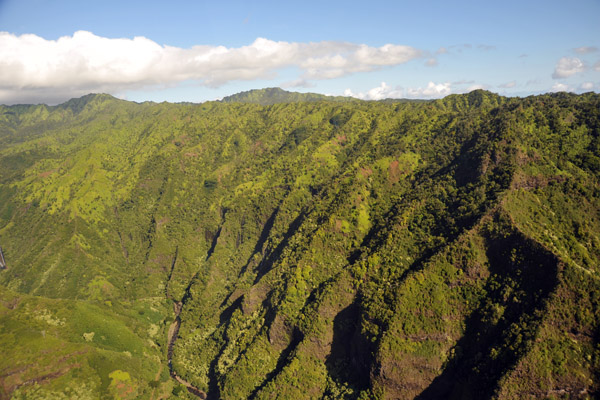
(0, 0, 600, 104)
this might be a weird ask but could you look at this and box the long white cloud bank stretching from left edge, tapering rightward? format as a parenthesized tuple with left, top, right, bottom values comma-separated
(0, 31, 423, 103)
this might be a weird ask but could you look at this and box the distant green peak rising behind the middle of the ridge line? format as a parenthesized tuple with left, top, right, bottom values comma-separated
(221, 88, 359, 106)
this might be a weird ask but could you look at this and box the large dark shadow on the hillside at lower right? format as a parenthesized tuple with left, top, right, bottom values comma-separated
(417, 220, 559, 399)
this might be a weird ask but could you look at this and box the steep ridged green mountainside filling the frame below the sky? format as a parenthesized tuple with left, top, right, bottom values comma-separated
(0, 91, 600, 399)
